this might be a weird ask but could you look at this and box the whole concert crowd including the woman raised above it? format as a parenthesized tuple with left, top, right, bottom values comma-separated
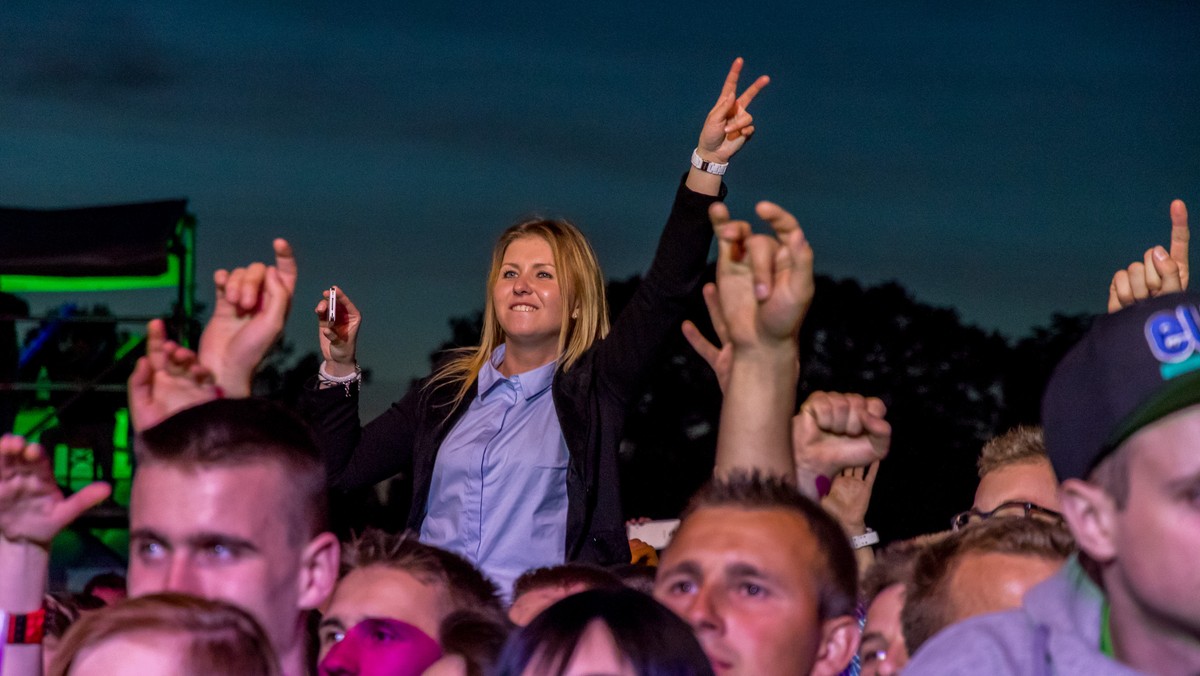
(0, 59, 1200, 676)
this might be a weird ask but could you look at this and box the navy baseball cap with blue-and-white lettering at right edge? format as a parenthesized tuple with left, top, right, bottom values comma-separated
(1042, 293, 1200, 481)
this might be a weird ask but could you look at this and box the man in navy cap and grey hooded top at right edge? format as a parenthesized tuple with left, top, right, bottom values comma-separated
(906, 293, 1200, 676)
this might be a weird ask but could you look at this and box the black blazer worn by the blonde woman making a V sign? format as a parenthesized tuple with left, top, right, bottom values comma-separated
(300, 177, 726, 564)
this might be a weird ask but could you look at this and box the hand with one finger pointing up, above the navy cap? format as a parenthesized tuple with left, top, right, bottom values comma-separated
(1109, 199, 1192, 312)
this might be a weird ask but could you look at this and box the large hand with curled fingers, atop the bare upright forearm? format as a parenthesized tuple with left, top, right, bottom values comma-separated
(708, 202, 814, 349)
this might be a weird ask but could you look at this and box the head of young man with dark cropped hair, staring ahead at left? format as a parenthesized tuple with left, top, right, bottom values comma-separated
(128, 399, 338, 674)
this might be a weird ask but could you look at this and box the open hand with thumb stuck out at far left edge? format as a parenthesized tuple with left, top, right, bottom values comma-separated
(0, 435, 112, 549)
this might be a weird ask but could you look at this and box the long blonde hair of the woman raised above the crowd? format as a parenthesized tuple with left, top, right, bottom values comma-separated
(428, 219, 608, 407)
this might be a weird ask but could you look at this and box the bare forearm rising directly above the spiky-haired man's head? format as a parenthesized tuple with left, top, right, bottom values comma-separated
(715, 345, 798, 481)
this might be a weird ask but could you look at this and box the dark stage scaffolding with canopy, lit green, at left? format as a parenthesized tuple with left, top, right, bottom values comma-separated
(0, 199, 197, 588)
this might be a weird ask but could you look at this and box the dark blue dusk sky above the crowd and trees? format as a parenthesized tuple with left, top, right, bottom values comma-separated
(0, 0, 1200, 412)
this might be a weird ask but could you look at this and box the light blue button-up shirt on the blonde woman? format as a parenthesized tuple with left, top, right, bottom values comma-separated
(421, 345, 570, 598)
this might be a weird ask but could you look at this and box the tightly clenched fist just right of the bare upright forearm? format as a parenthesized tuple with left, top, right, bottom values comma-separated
(792, 391, 892, 486)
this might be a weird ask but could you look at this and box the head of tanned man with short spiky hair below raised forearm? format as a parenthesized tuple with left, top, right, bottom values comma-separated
(654, 472, 858, 676)
